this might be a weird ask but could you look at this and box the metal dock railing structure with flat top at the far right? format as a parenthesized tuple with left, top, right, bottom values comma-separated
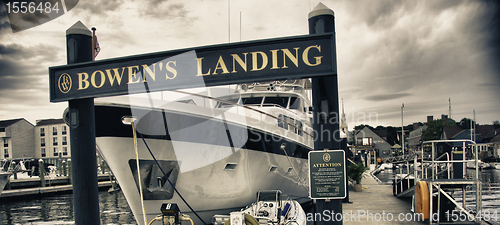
(393, 140, 482, 224)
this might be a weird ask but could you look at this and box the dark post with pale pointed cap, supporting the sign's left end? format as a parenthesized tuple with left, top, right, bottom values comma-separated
(66, 21, 101, 225)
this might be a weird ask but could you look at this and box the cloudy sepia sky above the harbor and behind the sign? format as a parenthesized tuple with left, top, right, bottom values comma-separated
(0, 0, 500, 128)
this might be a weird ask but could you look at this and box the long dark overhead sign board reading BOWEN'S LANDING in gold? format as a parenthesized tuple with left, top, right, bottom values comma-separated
(49, 33, 337, 102)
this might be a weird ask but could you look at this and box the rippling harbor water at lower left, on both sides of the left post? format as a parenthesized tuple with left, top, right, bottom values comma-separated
(0, 191, 136, 225)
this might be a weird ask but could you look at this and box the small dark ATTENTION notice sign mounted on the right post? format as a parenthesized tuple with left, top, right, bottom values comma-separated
(309, 150, 347, 199)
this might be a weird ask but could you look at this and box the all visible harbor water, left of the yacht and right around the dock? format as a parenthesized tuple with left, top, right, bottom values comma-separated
(0, 169, 500, 225)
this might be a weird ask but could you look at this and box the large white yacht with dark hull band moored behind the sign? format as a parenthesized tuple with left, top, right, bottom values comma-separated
(95, 80, 314, 224)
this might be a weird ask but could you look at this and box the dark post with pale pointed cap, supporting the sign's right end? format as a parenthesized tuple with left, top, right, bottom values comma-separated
(309, 3, 347, 225)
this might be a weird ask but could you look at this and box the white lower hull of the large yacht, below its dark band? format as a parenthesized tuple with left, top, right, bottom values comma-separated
(96, 137, 308, 224)
